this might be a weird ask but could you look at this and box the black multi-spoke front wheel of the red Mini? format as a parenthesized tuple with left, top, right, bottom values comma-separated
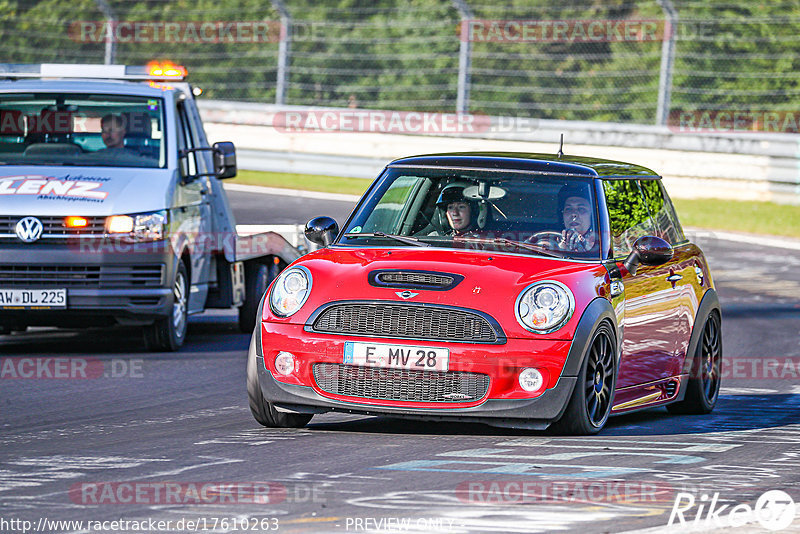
(552, 323, 617, 435)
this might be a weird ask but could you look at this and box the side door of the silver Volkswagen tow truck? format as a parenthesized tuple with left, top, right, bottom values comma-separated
(174, 102, 211, 313)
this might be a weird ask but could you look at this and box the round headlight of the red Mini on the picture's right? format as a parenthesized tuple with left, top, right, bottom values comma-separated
(514, 281, 575, 334)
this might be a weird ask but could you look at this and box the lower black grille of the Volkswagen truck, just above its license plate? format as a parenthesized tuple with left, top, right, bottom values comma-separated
(0, 263, 164, 288)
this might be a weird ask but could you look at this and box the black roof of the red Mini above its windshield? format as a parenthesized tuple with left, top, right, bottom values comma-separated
(389, 152, 660, 180)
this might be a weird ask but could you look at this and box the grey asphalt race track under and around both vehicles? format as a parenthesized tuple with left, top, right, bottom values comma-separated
(0, 189, 800, 533)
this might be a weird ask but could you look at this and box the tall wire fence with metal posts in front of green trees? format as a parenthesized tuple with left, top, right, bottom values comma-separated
(0, 0, 800, 128)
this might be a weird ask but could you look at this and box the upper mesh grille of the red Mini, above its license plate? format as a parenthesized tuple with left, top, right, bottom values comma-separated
(312, 303, 500, 343)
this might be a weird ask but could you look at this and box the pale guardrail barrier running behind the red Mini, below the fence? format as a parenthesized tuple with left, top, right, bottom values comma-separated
(200, 101, 800, 205)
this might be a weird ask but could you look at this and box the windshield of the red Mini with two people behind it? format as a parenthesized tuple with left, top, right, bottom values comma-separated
(339, 167, 601, 260)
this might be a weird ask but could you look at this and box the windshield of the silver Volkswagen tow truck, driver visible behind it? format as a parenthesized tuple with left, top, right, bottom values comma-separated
(0, 93, 166, 168)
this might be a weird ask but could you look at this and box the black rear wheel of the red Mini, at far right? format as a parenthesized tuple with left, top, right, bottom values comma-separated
(667, 311, 722, 415)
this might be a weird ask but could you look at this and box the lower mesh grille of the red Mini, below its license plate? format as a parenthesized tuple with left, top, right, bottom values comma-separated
(313, 363, 489, 403)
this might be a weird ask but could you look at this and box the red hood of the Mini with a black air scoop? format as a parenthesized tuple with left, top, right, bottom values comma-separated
(264, 247, 607, 339)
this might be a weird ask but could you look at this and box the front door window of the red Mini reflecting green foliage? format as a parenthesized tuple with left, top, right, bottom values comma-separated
(603, 180, 655, 257)
